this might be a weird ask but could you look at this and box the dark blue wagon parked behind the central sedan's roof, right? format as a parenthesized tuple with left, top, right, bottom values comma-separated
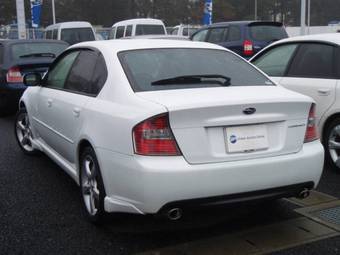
(191, 21, 288, 59)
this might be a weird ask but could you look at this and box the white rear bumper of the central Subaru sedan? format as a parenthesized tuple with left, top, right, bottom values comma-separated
(96, 141, 324, 214)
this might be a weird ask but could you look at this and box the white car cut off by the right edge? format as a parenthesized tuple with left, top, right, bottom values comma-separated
(251, 33, 340, 171)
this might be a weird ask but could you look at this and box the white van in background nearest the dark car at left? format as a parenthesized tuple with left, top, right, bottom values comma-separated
(44, 21, 96, 45)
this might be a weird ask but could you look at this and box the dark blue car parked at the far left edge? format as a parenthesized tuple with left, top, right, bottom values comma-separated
(0, 40, 68, 115)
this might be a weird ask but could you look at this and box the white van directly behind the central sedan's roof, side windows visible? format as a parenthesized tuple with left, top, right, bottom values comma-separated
(109, 19, 167, 39)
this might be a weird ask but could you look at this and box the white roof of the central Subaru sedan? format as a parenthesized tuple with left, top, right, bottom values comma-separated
(70, 39, 229, 53)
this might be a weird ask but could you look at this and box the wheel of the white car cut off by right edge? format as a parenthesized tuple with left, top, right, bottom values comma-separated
(323, 117, 340, 172)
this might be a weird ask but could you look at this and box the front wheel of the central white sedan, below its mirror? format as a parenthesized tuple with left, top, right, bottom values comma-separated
(14, 108, 39, 156)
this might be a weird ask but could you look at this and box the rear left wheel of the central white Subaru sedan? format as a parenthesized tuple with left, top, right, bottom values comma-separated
(79, 147, 106, 224)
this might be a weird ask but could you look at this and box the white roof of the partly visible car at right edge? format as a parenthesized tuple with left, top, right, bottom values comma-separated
(271, 33, 340, 46)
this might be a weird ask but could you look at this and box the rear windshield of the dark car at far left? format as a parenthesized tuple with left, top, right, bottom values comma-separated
(11, 42, 67, 60)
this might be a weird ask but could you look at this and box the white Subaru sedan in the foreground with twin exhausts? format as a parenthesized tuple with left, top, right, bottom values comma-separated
(15, 40, 324, 221)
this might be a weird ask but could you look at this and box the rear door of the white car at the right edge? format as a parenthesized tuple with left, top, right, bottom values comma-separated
(280, 43, 337, 123)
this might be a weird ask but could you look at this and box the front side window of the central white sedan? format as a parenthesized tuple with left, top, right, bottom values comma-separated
(45, 51, 79, 89)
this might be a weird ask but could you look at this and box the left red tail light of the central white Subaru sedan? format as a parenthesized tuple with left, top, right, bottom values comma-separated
(133, 114, 181, 156)
